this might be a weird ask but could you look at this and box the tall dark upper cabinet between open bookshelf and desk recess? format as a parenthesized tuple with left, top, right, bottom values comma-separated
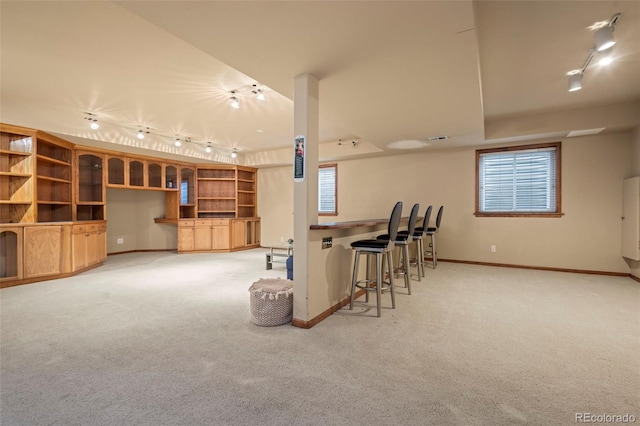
(75, 151, 106, 220)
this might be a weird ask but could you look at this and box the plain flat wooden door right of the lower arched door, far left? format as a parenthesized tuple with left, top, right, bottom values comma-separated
(24, 225, 62, 278)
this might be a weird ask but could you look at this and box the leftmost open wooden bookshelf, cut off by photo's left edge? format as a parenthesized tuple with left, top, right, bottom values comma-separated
(0, 124, 36, 223)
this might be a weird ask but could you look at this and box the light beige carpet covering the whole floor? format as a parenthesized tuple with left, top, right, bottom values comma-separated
(0, 249, 640, 426)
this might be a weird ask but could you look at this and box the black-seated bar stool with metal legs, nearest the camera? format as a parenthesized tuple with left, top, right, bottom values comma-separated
(349, 201, 402, 318)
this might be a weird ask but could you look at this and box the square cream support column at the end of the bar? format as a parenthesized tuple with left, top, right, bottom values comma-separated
(291, 74, 319, 324)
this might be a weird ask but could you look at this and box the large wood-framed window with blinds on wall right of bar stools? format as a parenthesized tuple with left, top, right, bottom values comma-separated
(475, 142, 562, 217)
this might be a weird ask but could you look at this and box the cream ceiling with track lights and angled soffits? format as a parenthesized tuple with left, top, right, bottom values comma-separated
(0, 0, 640, 165)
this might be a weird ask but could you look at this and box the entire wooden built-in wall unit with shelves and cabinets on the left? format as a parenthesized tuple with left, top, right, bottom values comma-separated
(0, 123, 260, 287)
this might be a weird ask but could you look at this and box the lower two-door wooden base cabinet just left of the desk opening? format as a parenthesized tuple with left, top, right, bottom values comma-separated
(71, 222, 106, 272)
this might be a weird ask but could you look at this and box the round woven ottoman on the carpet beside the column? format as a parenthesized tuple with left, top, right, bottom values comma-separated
(249, 278, 293, 327)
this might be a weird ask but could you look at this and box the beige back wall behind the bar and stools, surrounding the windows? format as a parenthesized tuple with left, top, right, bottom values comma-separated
(258, 133, 637, 273)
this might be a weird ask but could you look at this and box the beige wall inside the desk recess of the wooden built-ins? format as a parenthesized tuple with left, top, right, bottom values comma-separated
(106, 188, 178, 253)
